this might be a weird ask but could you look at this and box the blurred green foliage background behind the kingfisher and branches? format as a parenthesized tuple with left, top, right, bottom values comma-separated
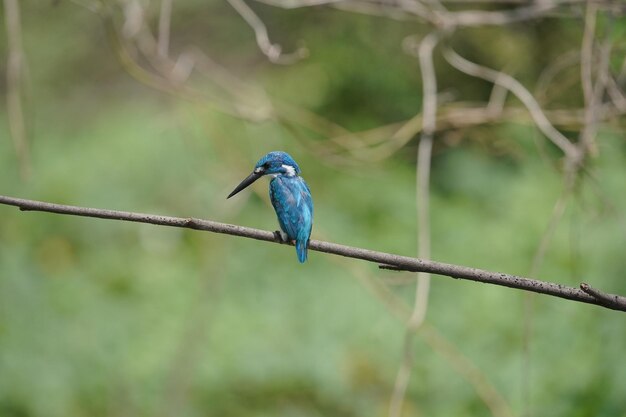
(0, 1, 626, 417)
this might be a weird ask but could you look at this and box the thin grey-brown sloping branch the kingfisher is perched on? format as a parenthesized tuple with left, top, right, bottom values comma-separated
(0, 195, 626, 311)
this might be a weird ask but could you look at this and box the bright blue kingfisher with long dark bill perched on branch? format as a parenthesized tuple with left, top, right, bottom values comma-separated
(226, 151, 313, 263)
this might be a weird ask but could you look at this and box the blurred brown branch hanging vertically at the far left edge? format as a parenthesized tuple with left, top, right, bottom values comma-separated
(4, 0, 31, 179)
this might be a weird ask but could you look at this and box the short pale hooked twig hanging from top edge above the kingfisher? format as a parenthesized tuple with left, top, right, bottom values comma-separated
(227, 0, 308, 64)
